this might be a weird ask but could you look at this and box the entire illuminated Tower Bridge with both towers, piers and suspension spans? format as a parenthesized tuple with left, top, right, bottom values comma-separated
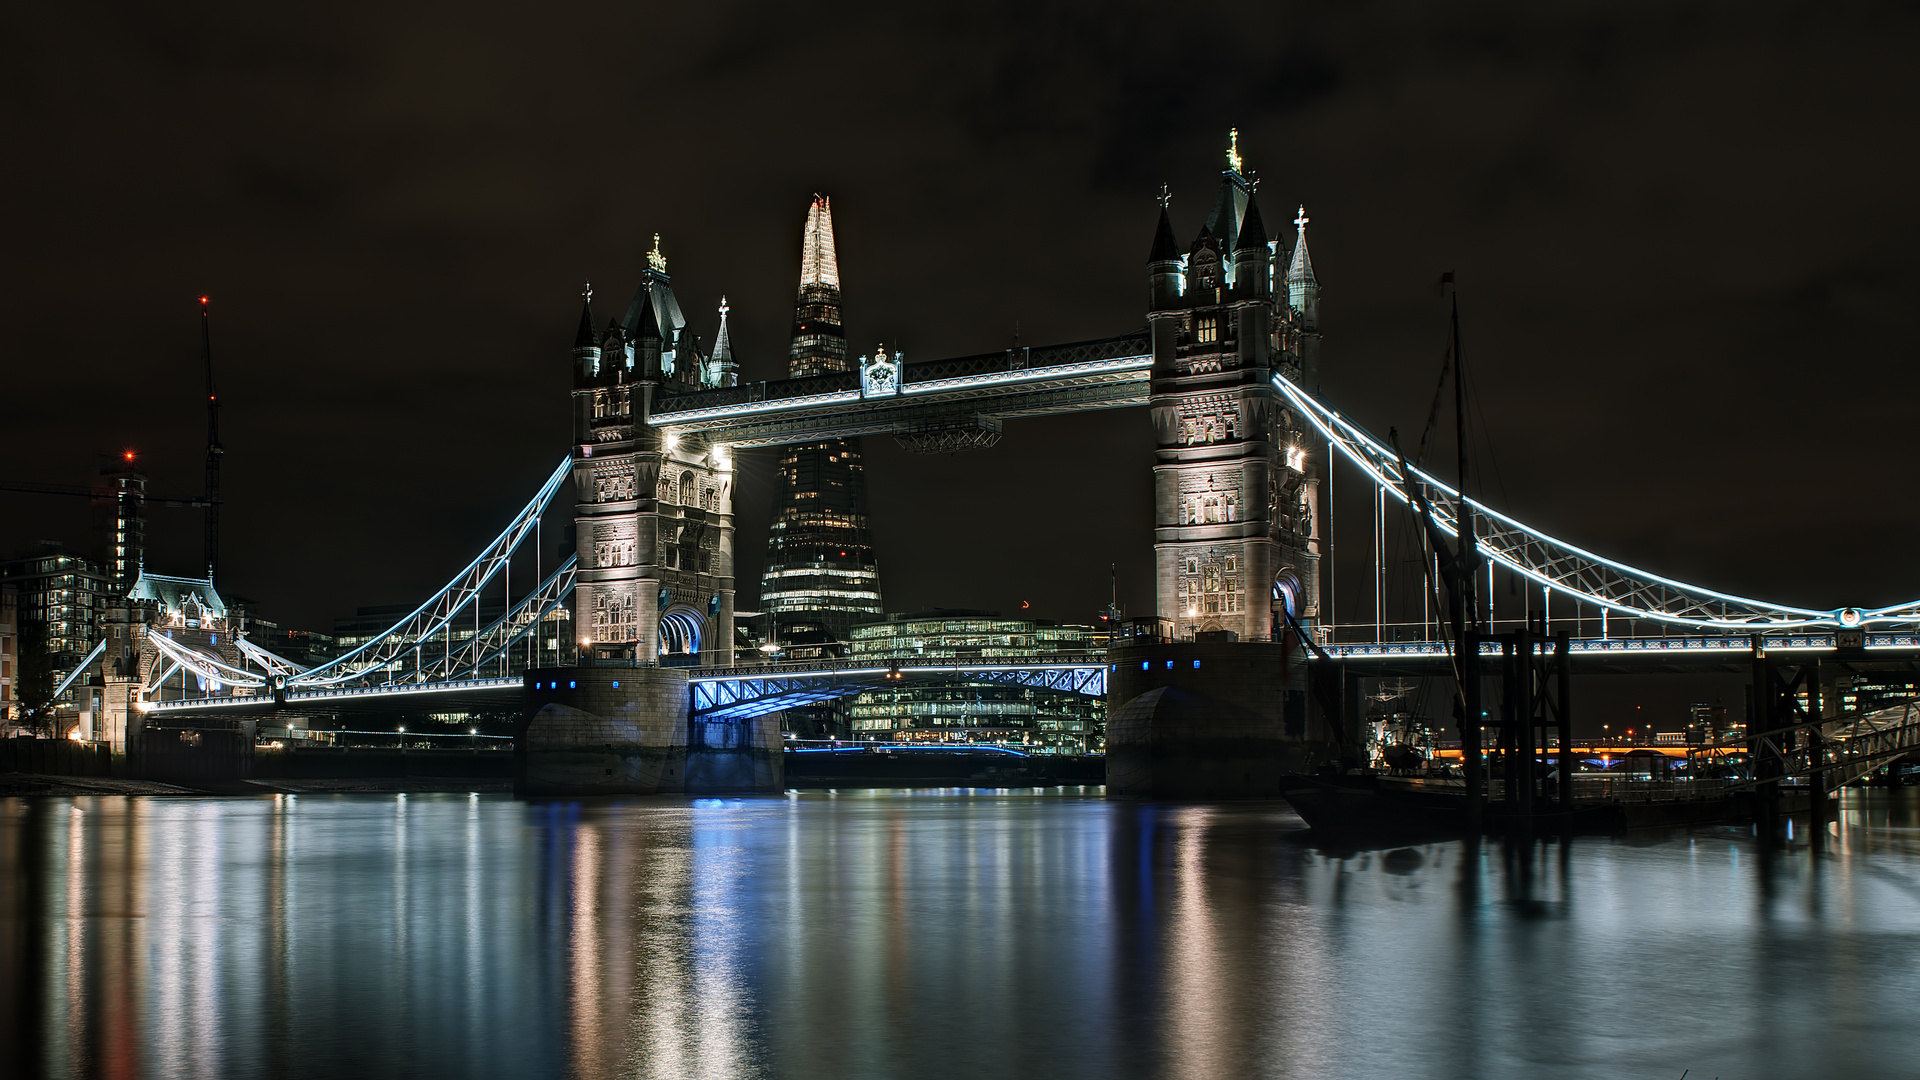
(60, 130, 1920, 792)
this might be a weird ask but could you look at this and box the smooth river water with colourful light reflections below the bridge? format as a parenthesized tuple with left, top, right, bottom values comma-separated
(0, 780, 1920, 1078)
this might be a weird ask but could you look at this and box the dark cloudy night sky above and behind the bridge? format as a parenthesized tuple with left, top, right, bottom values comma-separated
(0, 0, 1920, 722)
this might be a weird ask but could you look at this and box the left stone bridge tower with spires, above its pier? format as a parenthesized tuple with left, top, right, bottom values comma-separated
(572, 236, 733, 667)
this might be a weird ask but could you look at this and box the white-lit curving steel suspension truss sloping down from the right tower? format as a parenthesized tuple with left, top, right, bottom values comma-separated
(1273, 377, 1920, 632)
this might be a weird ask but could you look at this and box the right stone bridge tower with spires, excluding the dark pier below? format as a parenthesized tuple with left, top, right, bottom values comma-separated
(1148, 132, 1323, 642)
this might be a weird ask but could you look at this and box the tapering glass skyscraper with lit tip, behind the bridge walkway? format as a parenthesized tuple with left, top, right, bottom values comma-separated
(760, 194, 881, 651)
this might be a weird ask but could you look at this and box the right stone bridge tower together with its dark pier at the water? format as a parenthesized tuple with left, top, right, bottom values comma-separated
(1106, 136, 1348, 798)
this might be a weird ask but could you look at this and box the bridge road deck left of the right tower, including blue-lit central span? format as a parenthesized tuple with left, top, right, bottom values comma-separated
(142, 653, 1108, 723)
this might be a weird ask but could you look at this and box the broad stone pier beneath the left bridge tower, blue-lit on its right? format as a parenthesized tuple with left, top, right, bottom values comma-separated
(515, 665, 783, 796)
